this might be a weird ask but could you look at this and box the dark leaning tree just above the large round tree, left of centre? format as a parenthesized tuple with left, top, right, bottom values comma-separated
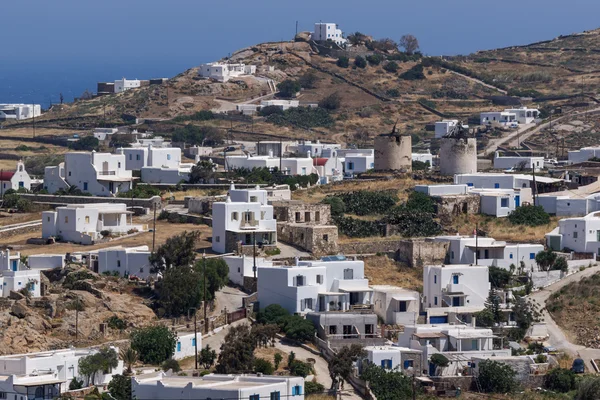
(148, 231, 200, 273)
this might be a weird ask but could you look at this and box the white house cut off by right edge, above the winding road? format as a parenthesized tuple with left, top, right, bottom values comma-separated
(546, 212, 600, 254)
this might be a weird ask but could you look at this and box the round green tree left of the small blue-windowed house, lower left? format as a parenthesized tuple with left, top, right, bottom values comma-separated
(130, 325, 177, 365)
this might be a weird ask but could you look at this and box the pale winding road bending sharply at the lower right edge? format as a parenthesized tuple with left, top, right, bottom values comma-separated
(529, 267, 600, 372)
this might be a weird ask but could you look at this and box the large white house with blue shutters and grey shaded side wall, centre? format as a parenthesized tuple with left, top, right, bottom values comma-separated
(257, 257, 373, 314)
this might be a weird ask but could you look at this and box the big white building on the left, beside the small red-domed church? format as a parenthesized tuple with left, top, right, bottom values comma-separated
(44, 151, 134, 197)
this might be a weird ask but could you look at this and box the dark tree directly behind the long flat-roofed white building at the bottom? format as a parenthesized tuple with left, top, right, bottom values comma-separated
(216, 325, 256, 374)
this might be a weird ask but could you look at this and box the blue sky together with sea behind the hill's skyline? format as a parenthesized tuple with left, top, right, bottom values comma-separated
(0, 0, 600, 106)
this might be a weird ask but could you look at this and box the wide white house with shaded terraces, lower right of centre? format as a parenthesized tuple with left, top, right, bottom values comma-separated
(398, 324, 511, 376)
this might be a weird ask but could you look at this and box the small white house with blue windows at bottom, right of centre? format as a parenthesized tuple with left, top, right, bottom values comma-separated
(359, 346, 423, 376)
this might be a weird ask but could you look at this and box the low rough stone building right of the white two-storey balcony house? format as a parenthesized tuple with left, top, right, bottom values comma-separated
(277, 222, 338, 255)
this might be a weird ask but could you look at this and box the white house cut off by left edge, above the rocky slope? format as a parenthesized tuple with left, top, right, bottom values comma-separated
(0, 250, 41, 297)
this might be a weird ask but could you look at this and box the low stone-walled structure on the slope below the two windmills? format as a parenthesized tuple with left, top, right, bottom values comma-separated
(395, 239, 450, 267)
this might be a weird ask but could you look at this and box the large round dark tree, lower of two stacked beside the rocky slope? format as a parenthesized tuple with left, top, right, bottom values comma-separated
(155, 267, 203, 316)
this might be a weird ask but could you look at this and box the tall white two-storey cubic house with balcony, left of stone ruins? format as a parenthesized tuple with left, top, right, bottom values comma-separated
(212, 184, 277, 253)
